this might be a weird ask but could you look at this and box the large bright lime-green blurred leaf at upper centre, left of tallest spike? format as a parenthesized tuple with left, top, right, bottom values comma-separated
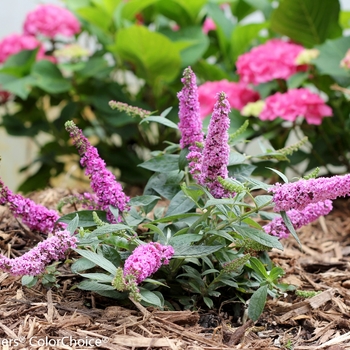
(111, 26, 181, 84)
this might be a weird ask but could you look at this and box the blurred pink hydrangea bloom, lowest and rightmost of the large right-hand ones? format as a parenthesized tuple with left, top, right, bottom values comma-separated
(259, 88, 333, 125)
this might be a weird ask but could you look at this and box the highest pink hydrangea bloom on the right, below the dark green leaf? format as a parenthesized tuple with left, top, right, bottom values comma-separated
(236, 39, 306, 84)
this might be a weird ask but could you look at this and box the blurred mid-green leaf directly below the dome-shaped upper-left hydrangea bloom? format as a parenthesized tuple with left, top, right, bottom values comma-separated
(31, 60, 71, 94)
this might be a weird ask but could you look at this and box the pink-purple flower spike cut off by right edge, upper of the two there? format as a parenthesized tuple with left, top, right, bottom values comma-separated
(269, 174, 350, 212)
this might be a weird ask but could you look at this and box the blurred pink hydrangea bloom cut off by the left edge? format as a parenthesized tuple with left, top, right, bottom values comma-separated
(0, 34, 45, 63)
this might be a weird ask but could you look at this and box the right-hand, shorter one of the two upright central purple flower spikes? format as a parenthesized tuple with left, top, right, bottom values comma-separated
(200, 92, 231, 198)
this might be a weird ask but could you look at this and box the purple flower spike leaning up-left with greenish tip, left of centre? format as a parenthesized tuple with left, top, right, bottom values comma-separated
(65, 121, 129, 222)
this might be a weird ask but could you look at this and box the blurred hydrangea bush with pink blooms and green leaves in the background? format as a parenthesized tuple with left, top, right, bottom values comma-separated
(0, 0, 350, 192)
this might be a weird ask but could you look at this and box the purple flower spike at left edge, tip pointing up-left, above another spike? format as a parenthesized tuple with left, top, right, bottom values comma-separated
(0, 180, 66, 234)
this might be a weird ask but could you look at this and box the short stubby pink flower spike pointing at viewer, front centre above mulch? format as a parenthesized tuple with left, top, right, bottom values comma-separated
(124, 242, 174, 284)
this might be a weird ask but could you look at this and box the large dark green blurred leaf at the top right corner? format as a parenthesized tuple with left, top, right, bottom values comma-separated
(271, 0, 342, 47)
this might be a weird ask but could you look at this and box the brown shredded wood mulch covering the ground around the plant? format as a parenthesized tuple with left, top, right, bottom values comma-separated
(0, 190, 350, 350)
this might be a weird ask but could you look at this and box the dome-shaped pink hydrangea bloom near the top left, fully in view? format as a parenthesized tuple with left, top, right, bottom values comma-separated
(23, 4, 80, 39)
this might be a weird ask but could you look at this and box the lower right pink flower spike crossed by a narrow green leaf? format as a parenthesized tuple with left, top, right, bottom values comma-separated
(263, 200, 333, 239)
